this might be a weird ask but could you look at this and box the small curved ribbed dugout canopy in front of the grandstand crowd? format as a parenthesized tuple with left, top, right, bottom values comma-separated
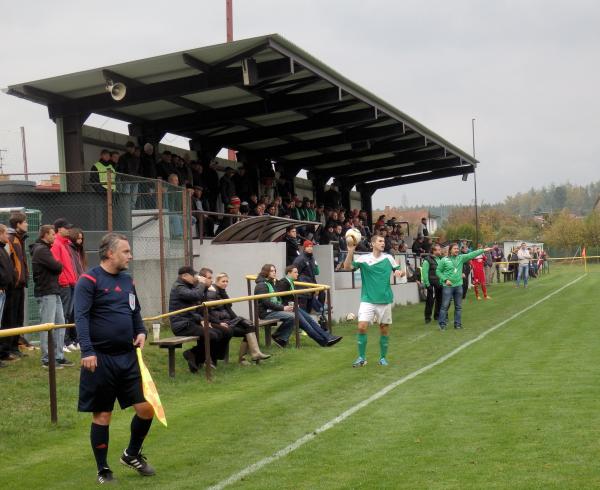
(211, 216, 321, 245)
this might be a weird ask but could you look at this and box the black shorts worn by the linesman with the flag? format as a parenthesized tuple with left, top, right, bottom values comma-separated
(78, 351, 145, 412)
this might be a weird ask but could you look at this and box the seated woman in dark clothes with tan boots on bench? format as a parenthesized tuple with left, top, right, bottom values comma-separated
(206, 272, 271, 365)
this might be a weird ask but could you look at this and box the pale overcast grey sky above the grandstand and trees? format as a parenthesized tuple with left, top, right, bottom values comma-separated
(0, 0, 600, 207)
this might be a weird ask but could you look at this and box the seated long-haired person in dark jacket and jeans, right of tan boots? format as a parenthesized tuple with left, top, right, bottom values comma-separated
(254, 264, 294, 347)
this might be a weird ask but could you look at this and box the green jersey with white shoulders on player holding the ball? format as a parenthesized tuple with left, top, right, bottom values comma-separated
(352, 253, 401, 305)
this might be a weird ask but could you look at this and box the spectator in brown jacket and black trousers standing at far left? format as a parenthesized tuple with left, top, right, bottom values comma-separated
(2, 212, 29, 357)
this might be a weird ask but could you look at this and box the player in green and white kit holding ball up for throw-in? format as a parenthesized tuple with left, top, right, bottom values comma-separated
(344, 235, 405, 367)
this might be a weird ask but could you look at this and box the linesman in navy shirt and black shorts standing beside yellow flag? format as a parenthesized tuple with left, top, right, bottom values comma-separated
(75, 233, 154, 484)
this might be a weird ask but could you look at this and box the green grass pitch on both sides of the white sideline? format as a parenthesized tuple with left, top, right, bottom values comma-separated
(0, 266, 600, 489)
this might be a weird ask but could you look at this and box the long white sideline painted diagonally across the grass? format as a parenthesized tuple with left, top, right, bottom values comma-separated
(208, 273, 587, 490)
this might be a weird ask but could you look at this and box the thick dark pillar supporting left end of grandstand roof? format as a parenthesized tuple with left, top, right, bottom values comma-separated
(56, 114, 89, 192)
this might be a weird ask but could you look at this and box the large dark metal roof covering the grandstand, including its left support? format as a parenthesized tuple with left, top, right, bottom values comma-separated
(5, 34, 477, 201)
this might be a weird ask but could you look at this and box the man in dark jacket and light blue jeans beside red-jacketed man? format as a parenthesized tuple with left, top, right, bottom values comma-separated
(30, 225, 73, 368)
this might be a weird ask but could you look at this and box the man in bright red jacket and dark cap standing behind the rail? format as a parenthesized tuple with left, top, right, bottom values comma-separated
(51, 218, 77, 352)
